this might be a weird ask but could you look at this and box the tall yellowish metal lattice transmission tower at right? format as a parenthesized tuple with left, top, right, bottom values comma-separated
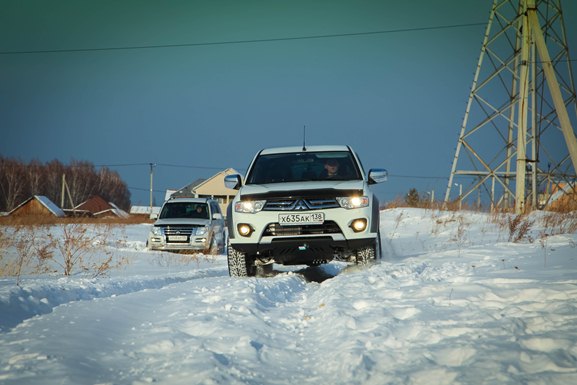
(445, 0, 577, 213)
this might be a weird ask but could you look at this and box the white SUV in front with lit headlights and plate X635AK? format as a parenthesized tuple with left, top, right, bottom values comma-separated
(225, 146, 387, 276)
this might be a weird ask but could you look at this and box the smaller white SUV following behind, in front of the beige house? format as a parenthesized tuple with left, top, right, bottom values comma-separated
(147, 198, 226, 254)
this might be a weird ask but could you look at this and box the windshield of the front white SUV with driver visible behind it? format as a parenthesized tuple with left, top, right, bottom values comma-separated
(246, 151, 362, 184)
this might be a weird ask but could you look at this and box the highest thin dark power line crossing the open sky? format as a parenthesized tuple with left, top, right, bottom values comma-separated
(0, 22, 487, 55)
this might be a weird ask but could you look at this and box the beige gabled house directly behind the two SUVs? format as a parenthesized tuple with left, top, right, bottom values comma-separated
(167, 168, 239, 215)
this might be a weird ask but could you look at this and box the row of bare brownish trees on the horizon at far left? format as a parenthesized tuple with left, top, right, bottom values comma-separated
(0, 156, 130, 211)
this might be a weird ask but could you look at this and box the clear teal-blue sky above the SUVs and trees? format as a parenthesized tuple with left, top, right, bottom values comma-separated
(0, 0, 577, 205)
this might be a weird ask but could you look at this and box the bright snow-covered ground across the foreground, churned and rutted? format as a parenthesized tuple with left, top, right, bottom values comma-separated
(0, 209, 577, 385)
